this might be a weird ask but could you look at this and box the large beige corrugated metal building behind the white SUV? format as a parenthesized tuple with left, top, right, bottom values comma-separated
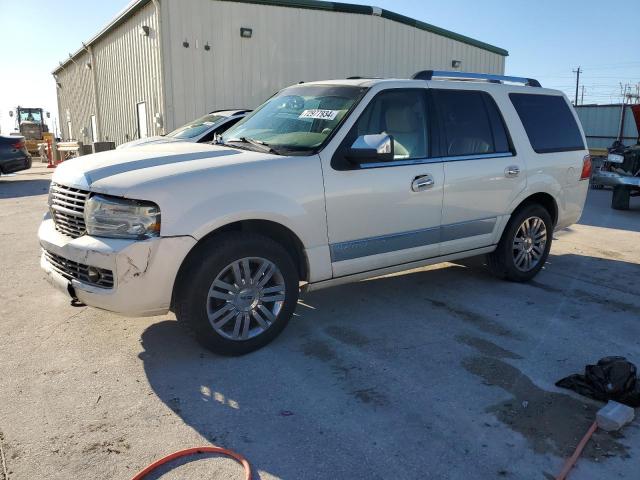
(53, 0, 508, 144)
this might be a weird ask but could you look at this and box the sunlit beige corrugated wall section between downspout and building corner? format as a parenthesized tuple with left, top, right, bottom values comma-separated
(93, 3, 164, 144)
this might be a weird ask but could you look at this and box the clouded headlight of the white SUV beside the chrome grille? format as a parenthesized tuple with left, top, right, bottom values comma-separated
(84, 195, 160, 239)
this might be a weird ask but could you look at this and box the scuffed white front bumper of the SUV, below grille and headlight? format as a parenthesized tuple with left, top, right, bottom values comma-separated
(38, 218, 196, 316)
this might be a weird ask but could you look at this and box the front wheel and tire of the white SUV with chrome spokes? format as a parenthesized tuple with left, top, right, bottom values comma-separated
(175, 232, 299, 355)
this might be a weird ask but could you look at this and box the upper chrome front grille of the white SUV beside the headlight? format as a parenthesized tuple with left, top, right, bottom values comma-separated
(49, 182, 90, 238)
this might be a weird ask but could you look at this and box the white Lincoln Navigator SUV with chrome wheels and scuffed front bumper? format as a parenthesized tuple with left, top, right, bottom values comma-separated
(39, 71, 591, 355)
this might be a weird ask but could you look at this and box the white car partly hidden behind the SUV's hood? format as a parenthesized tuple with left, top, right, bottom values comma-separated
(117, 110, 251, 149)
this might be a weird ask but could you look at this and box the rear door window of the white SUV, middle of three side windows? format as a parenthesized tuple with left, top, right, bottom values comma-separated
(433, 90, 510, 156)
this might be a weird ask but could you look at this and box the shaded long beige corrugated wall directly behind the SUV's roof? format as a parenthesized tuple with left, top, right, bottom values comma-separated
(162, 0, 504, 129)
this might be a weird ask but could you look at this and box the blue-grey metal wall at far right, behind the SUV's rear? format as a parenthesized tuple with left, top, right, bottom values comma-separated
(575, 105, 638, 148)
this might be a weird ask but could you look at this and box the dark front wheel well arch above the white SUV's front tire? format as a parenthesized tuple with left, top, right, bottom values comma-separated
(171, 220, 309, 307)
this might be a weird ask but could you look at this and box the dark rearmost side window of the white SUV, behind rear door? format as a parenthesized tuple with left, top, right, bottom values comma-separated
(509, 93, 585, 153)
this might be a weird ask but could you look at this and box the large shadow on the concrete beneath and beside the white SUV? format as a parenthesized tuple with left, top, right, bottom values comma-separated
(140, 254, 640, 480)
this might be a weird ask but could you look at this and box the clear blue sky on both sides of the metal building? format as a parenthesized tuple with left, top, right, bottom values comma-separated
(0, 0, 640, 133)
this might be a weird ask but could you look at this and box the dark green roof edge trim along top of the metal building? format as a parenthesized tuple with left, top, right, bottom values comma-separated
(223, 0, 509, 57)
